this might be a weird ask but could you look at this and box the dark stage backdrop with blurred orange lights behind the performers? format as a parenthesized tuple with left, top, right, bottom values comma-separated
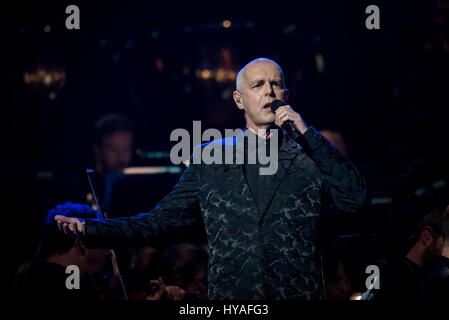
(0, 0, 449, 297)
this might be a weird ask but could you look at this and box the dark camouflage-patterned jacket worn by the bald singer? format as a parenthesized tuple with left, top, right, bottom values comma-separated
(82, 127, 366, 300)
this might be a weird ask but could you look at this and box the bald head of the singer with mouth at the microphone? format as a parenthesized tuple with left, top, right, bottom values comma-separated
(233, 58, 288, 129)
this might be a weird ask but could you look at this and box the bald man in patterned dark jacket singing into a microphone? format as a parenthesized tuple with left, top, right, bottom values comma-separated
(56, 58, 366, 300)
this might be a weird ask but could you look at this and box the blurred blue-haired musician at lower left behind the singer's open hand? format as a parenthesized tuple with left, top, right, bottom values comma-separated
(13, 202, 110, 301)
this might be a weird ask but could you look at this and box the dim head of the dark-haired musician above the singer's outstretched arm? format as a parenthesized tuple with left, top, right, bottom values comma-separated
(93, 114, 134, 172)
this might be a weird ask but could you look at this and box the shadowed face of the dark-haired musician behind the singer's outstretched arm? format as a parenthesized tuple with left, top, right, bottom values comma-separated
(100, 131, 133, 171)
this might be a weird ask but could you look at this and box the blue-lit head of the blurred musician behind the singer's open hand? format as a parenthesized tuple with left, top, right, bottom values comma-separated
(40, 202, 109, 273)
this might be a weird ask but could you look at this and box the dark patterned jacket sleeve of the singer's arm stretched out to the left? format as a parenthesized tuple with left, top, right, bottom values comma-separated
(84, 157, 201, 248)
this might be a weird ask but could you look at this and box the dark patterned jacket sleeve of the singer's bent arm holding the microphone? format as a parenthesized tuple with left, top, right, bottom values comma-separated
(303, 127, 368, 212)
